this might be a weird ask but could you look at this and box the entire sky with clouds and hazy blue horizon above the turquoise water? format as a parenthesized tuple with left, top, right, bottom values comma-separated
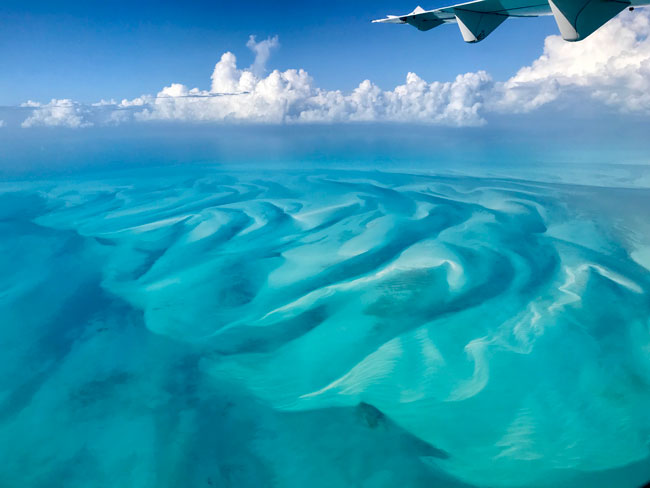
(0, 0, 650, 173)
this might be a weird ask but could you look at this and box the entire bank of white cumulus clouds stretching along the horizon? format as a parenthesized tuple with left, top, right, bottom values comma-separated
(16, 13, 650, 128)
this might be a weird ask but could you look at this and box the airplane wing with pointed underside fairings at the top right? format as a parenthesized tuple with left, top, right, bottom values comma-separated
(373, 0, 637, 42)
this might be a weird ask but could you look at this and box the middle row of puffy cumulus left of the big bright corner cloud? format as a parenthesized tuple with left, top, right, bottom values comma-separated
(133, 44, 492, 126)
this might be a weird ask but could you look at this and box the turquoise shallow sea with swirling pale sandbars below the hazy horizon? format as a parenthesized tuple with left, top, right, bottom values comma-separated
(0, 166, 650, 488)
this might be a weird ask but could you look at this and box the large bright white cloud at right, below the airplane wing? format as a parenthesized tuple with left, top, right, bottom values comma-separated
(495, 12, 650, 114)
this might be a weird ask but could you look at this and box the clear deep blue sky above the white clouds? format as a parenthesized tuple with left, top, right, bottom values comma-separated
(0, 0, 556, 105)
